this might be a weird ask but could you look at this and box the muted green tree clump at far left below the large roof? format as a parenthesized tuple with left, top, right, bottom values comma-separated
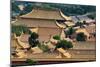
(11, 25, 31, 36)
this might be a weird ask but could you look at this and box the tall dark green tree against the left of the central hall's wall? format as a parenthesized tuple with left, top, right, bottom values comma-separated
(28, 32, 39, 47)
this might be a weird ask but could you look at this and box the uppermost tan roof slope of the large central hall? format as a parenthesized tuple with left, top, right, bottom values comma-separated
(20, 9, 65, 20)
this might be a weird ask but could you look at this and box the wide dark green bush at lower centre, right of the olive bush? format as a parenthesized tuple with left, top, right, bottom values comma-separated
(56, 40, 73, 49)
